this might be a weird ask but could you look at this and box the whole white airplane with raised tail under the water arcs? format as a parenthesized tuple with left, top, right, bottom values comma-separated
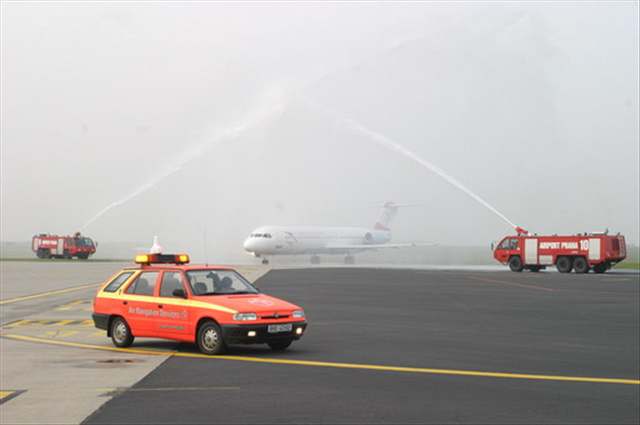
(243, 202, 434, 264)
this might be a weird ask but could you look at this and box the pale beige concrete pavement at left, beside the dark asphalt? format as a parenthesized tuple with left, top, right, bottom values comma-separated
(0, 263, 269, 424)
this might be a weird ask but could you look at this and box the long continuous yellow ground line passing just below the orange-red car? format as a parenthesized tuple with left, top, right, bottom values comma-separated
(2, 334, 640, 385)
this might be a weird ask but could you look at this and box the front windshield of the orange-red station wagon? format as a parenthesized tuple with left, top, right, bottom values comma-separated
(187, 270, 259, 295)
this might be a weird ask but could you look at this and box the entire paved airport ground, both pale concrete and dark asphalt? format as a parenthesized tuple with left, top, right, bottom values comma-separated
(0, 263, 640, 424)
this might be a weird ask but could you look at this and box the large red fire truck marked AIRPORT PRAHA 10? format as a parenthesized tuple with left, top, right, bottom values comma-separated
(492, 227, 627, 273)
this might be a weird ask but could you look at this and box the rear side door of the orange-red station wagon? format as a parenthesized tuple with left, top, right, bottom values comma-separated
(123, 271, 160, 336)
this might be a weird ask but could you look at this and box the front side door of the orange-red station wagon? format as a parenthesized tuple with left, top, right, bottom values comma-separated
(154, 270, 191, 339)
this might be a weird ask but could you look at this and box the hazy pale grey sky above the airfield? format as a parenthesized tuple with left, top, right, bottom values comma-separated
(0, 2, 640, 257)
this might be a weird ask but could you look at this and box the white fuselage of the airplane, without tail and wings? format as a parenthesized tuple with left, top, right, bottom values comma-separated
(244, 226, 391, 257)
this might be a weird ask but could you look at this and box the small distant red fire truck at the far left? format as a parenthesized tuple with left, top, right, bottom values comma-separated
(31, 232, 98, 260)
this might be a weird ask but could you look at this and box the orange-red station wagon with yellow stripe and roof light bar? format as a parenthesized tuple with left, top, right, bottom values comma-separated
(93, 254, 307, 354)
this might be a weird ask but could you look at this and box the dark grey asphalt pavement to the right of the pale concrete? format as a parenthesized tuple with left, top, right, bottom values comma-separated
(85, 268, 640, 424)
